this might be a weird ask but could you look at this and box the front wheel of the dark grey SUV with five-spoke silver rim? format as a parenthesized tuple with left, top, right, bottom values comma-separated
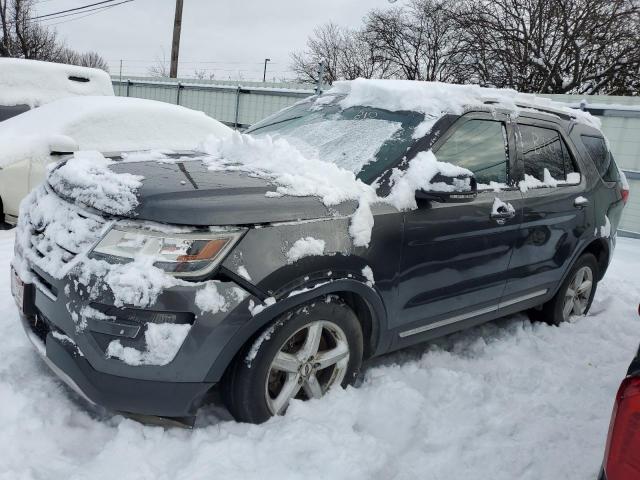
(222, 297, 363, 423)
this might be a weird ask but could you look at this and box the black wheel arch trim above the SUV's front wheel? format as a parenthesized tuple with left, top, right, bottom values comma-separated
(205, 279, 387, 382)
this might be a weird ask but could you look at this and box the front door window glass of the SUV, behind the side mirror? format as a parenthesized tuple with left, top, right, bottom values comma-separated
(435, 119, 509, 187)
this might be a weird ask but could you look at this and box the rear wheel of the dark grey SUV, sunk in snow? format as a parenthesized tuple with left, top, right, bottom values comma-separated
(529, 253, 599, 325)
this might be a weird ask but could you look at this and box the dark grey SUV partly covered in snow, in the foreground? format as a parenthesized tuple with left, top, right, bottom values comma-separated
(12, 80, 628, 422)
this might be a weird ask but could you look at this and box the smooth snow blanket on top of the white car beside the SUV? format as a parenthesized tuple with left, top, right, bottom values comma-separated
(0, 97, 231, 166)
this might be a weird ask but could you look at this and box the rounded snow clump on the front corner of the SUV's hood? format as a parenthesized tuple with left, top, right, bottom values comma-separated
(48, 152, 143, 215)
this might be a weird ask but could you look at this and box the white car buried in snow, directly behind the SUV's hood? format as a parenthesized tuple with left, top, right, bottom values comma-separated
(0, 96, 231, 224)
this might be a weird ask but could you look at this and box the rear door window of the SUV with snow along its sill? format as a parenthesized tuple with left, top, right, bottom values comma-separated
(519, 125, 580, 183)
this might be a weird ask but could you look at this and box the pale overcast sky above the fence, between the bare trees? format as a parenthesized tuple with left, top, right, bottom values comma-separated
(36, 0, 400, 80)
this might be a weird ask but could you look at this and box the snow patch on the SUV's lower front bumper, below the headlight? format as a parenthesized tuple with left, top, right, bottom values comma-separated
(107, 323, 191, 366)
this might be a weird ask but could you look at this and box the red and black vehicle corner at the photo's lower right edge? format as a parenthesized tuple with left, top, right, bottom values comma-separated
(599, 305, 640, 480)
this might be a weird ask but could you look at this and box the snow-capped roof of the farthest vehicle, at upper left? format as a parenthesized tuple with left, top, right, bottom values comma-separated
(0, 58, 113, 107)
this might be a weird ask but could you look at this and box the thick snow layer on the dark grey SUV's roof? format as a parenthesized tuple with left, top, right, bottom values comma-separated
(327, 78, 600, 133)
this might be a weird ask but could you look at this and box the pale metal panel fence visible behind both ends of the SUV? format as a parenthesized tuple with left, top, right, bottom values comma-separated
(113, 77, 640, 238)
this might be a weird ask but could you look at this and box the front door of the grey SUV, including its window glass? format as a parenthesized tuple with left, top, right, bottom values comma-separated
(391, 113, 522, 336)
